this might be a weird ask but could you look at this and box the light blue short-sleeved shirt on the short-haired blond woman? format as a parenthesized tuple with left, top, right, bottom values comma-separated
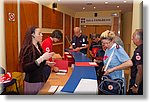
(104, 43, 130, 79)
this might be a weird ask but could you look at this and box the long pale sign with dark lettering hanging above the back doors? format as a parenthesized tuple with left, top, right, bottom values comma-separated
(80, 17, 112, 25)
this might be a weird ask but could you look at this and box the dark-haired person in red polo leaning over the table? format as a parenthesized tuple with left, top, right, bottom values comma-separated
(42, 30, 63, 61)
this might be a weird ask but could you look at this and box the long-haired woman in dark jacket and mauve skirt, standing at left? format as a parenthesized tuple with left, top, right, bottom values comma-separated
(19, 27, 54, 95)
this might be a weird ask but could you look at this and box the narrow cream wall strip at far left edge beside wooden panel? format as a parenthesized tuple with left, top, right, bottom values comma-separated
(0, 0, 6, 68)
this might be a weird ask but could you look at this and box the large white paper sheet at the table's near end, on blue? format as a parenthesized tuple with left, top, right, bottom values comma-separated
(74, 79, 98, 95)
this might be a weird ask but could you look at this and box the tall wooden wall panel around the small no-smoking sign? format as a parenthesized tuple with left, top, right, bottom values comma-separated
(4, 0, 18, 72)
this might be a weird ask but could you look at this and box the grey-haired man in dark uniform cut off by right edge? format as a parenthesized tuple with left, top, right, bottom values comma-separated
(129, 29, 143, 95)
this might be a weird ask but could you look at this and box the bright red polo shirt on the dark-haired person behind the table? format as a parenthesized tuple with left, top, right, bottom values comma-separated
(42, 37, 53, 61)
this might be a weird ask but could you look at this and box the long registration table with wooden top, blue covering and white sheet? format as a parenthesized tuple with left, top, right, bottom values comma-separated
(38, 52, 98, 94)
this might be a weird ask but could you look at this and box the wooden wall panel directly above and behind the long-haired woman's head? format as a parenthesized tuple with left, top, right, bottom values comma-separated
(20, 1, 39, 45)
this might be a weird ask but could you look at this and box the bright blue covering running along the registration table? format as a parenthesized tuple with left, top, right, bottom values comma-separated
(61, 52, 97, 93)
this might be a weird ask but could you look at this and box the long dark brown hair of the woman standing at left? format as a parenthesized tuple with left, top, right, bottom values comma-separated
(19, 26, 38, 69)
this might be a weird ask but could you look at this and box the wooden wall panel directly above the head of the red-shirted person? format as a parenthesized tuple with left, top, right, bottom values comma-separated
(42, 6, 63, 29)
